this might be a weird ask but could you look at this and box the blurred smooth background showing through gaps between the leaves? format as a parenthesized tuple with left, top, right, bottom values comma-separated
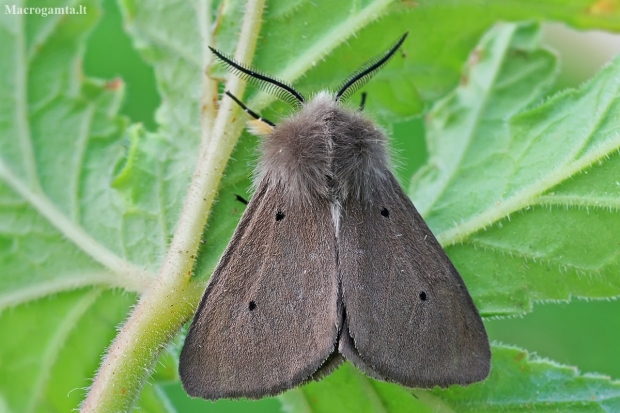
(84, 0, 620, 413)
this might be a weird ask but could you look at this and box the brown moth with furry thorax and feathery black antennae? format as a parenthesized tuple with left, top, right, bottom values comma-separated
(179, 34, 491, 400)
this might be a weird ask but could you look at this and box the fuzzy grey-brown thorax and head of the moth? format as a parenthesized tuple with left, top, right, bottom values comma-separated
(255, 92, 389, 202)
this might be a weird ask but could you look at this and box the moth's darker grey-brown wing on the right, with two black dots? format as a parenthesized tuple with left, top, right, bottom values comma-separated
(338, 175, 491, 388)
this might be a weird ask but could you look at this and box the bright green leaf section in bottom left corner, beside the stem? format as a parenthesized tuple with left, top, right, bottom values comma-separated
(0, 288, 135, 412)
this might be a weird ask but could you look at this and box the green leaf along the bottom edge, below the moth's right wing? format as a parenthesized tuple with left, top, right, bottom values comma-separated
(280, 345, 620, 413)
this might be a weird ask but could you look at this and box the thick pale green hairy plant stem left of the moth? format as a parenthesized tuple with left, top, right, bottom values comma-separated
(81, 0, 265, 412)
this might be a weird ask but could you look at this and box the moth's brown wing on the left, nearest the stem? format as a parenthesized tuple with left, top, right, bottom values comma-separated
(179, 182, 340, 399)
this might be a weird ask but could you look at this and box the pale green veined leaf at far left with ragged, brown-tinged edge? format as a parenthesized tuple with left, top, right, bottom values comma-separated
(0, 6, 147, 302)
